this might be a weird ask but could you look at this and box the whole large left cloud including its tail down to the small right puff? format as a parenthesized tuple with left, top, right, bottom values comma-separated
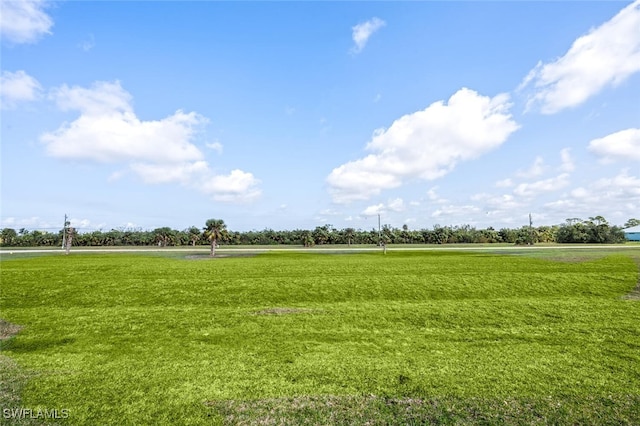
(40, 82, 260, 205)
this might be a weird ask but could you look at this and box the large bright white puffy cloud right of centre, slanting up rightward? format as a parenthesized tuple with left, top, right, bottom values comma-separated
(327, 88, 518, 203)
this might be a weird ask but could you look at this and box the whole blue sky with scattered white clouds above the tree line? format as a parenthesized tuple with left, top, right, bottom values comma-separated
(0, 0, 640, 231)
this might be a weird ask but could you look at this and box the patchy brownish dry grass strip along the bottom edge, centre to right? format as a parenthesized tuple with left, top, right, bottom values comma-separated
(205, 395, 640, 425)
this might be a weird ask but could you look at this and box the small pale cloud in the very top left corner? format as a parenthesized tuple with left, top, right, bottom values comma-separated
(0, 0, 53, 43)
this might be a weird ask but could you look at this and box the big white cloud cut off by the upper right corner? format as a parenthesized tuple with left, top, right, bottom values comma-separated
(519, 0, 640, 114)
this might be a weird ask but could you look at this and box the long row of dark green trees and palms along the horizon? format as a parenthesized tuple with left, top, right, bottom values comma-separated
(0, 216, 640, 250)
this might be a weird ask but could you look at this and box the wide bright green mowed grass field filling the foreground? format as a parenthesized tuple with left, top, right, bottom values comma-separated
(0, 251, 640, 425)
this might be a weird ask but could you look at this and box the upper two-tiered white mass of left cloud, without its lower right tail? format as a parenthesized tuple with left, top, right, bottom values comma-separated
(40, 81, 206, 163)
